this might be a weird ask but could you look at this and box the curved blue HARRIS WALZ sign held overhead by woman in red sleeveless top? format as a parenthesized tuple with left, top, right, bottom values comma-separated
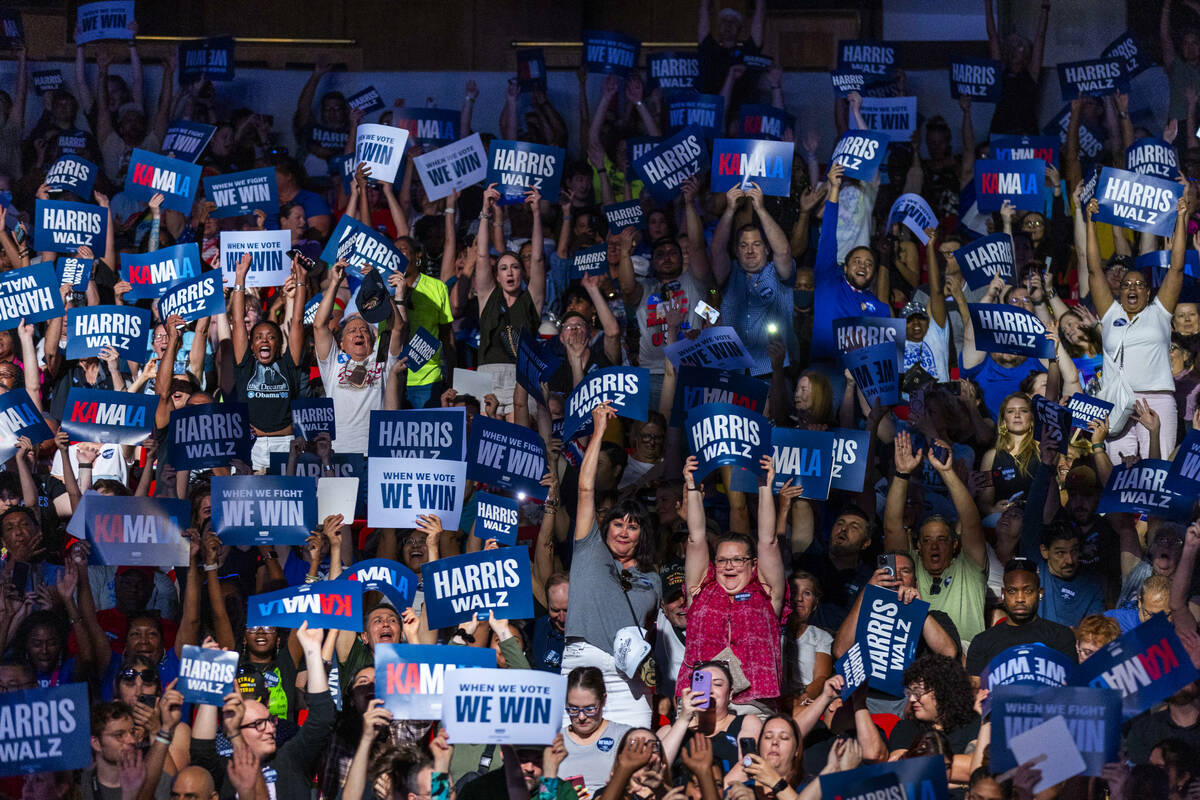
(684, 403, 772, 480)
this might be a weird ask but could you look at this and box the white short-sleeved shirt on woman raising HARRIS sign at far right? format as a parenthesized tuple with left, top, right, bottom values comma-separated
(1100, 297, 1175, 392)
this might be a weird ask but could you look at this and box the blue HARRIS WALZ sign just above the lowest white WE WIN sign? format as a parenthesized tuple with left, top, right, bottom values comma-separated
(421, 547, 533, 630)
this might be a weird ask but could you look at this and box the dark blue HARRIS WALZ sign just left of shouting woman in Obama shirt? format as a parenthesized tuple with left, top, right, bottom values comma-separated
(167, 403, 252, 469)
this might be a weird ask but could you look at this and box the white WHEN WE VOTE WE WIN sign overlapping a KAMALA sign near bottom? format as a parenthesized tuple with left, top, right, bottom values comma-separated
(442, 668, 568, 748)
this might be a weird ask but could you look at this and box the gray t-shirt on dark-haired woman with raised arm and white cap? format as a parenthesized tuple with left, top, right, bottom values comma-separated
(566, 524, 662, 655)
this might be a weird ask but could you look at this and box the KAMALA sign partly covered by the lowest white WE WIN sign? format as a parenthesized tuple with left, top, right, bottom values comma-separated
(374, 642, 496, 720)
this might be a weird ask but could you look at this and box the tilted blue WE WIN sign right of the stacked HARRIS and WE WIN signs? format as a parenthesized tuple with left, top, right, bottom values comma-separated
(467, 415, 547, 500)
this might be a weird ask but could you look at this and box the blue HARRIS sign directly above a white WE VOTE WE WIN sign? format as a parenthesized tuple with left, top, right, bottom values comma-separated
(367, 408, 465, 460)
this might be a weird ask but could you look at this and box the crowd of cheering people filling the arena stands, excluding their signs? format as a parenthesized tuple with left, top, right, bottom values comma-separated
(0, 0, 1200, 800)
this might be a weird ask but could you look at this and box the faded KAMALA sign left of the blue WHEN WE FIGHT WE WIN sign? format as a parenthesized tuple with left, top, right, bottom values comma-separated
(84, 494, 192, 570)
